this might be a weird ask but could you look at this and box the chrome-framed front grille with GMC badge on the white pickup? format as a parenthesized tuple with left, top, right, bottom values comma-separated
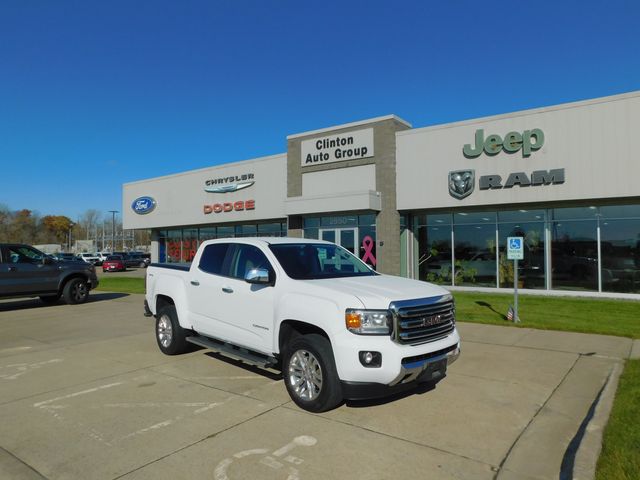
(390, 295, 456, 345)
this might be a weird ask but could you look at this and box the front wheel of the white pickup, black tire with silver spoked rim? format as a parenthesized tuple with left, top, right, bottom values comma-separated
(282, 333, 343, 413)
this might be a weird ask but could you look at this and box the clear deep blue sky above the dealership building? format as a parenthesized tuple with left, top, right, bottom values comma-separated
(0, 0, 640, 219)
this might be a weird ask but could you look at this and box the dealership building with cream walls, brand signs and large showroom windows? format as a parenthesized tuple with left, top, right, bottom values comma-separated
(123, 92, 640, 294)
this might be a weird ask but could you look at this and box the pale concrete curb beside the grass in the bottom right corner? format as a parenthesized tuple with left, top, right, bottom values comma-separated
(572, 363, 624, 480)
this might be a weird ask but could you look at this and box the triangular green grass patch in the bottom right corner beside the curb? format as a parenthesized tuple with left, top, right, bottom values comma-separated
(596, 360, 640, 480)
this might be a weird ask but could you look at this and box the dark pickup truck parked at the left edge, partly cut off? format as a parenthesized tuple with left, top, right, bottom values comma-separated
(0, 243, 98, 305)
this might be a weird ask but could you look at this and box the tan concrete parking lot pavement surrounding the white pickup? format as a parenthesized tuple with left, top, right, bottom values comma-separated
(0, 292, 632, 480)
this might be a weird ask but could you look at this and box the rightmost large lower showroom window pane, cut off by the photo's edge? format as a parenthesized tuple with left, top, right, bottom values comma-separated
(600, 219, 640, 293)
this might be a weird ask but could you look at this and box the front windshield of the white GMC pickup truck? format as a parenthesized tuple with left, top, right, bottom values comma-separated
(269, 243, 377, 280)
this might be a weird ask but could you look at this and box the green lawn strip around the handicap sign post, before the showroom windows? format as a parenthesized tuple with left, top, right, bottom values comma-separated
(453, 292, 640, 340)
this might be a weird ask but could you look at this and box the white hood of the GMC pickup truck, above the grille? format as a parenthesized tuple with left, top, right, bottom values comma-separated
(307, 275, 449, 310)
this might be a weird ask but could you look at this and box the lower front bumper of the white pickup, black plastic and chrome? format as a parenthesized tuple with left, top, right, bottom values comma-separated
(340, 343, 460, 400)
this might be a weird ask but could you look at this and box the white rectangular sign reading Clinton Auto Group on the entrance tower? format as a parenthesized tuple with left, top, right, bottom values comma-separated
(301, 128, 374, 167)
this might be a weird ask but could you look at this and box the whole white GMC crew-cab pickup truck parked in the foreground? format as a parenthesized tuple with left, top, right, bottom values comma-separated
(145, 238, 460, 412)
